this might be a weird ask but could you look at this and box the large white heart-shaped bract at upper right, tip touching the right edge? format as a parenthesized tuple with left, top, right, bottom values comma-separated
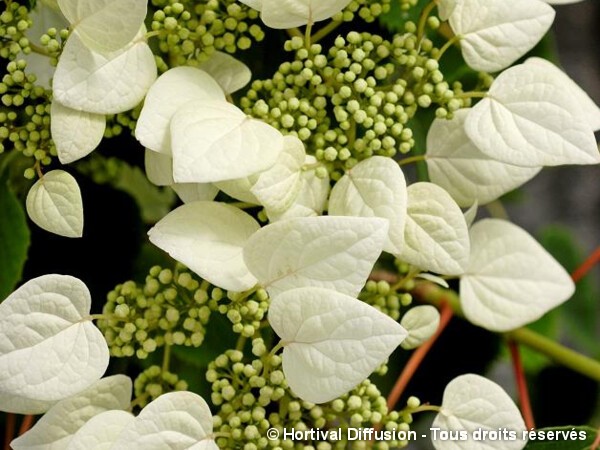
(465, 60, 600, 167)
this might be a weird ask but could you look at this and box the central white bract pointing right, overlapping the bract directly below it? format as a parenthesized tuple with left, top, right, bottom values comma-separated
(244, 216, 389, 297)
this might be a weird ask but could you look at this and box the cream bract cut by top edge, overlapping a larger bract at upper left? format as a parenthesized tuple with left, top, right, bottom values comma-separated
(58, 0, 148, 52)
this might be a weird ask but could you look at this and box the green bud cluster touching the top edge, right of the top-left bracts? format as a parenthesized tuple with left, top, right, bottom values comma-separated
(151, 0, 264, 72)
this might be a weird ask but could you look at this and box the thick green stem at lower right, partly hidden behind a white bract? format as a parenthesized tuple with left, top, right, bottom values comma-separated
(412, 282, 600, 382)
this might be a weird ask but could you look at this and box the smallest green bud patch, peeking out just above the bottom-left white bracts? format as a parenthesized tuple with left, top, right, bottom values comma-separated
(133, 366, 188, 409)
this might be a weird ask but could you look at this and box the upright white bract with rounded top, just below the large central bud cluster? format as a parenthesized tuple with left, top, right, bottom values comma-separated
(329, 156, 407, 253)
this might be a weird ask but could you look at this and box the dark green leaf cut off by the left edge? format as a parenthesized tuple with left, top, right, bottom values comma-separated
(0, 177, 30, 300)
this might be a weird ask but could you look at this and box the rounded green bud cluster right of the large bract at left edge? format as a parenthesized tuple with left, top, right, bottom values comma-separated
(98, 264, 216, 359)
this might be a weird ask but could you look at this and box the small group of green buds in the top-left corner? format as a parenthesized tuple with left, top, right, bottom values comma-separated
(0, 1, 33, 61)
